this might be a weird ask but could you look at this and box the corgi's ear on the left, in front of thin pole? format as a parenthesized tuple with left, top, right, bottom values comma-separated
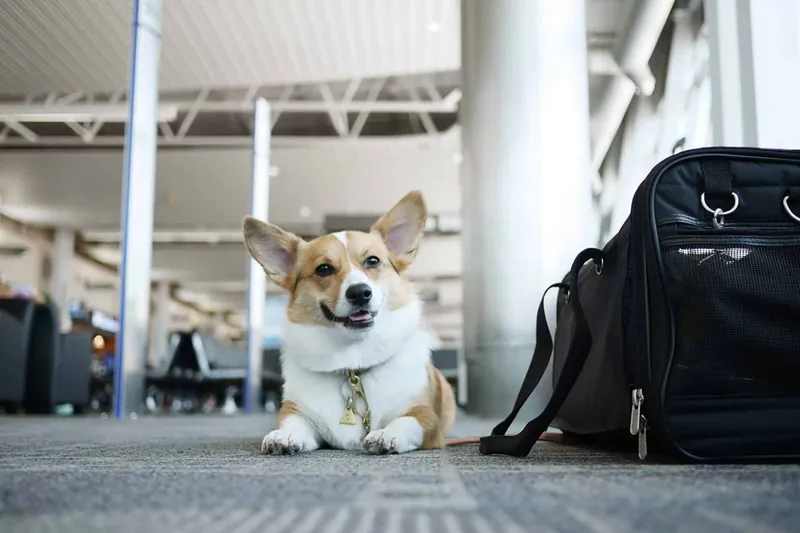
(242, 217, 303, 290)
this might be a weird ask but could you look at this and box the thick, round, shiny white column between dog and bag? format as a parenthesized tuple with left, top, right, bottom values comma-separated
(460, 0, 598, 418)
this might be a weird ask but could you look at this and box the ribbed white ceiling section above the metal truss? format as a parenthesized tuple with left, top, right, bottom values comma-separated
(0, 0, 635, 94)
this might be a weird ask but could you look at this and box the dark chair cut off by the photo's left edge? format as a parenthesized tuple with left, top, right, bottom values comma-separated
(0, 299, 28, 413)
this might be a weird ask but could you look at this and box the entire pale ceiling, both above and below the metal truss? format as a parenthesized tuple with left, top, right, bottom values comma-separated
(0, 0, 638, 338)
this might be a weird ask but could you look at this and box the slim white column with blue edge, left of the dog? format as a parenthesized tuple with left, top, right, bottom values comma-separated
(114, 0, 162, 418)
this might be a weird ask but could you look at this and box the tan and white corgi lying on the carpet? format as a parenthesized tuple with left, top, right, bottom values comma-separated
(243, 191, 456, 454)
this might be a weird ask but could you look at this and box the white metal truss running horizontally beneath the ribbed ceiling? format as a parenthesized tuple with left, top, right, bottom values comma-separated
(0, 76, 461, 146)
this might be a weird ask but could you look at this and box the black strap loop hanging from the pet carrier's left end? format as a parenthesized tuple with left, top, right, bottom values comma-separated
(479, 248, 605, 457)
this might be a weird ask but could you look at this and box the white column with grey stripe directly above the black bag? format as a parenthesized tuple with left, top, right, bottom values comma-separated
(705, 0, 800, 149)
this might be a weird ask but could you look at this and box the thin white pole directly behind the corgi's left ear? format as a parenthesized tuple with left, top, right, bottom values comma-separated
(244, 98, 272, 414)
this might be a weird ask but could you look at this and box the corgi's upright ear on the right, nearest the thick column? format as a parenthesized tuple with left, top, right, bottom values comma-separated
(372, 191, 428, 271)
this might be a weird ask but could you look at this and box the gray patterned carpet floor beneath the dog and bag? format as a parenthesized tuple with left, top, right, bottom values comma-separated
(0, 416, 800, 533)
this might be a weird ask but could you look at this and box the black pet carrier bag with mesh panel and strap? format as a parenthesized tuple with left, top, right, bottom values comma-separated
(480, 148, 800, 461)
